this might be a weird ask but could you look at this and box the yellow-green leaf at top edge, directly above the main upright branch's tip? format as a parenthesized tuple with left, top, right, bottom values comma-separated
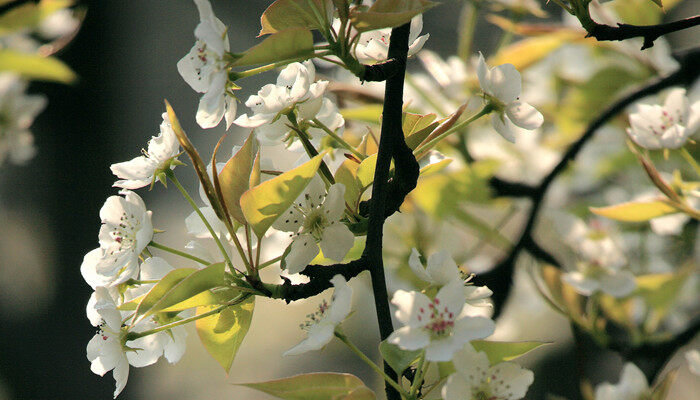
(350, 0, 437, 31)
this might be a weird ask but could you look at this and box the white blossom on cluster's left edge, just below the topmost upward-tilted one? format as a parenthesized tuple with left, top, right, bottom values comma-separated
(80, 190, 153, 288)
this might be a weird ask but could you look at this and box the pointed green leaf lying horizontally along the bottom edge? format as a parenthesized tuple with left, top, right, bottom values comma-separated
(239, 372, 372, 400)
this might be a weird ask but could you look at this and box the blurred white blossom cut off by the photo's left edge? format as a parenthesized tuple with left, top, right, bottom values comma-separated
(0, 72, 46, 165)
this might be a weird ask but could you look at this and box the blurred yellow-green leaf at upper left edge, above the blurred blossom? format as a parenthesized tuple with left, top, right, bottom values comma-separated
(0, 50, 77, 83)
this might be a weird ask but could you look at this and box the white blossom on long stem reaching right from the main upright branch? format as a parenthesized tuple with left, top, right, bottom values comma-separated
(476, 54, 544, 142)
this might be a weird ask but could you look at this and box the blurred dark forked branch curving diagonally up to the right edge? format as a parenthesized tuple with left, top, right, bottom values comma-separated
(475, 49, 700, 318)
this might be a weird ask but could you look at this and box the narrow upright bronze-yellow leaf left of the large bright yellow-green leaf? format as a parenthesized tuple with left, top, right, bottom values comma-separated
(219, 135, 258, 224)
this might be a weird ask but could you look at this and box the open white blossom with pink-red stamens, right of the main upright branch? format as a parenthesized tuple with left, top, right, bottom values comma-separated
(387, 282, 495, 361)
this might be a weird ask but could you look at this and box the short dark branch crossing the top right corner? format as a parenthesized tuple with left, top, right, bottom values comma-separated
(586, 15, 700, 50)
